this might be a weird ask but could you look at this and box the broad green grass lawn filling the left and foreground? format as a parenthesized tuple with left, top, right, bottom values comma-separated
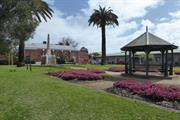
(0, 66, 180, 120)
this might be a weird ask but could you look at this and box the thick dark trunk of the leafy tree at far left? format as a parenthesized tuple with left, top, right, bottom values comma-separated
(17, 40, 24, 67)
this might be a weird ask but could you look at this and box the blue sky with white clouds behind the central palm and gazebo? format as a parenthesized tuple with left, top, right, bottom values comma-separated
(28, 0, 180, 53)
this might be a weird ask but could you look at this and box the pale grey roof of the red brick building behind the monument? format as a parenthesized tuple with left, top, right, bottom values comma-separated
(25, 43, 78, 51)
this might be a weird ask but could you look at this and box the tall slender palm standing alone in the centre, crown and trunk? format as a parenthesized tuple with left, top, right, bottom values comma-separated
(88, 6, 119, 65)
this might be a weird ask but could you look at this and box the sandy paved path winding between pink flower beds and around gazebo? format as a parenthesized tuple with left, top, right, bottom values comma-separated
(71, 67, 180, 90)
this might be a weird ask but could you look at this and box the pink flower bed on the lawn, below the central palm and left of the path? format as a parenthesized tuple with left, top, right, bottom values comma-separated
(48, 69, 104, 80)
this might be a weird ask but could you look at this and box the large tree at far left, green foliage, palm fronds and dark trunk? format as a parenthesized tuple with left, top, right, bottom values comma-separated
(0, 0, 53, 66)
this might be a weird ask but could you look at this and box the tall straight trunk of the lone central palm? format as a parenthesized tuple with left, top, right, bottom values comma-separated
(101, 25, 106, 65)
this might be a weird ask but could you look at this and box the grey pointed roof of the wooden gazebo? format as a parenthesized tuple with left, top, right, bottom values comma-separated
(121, 28, 177, 51)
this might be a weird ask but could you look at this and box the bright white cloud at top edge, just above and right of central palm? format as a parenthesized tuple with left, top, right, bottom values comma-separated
(88, 0, 164, 20)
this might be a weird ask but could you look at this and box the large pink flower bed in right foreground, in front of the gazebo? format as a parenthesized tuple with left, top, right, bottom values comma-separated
(113, 80, 180, 102)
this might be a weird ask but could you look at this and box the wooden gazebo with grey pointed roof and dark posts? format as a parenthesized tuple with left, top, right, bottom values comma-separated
(121, 27, 178, 77)
